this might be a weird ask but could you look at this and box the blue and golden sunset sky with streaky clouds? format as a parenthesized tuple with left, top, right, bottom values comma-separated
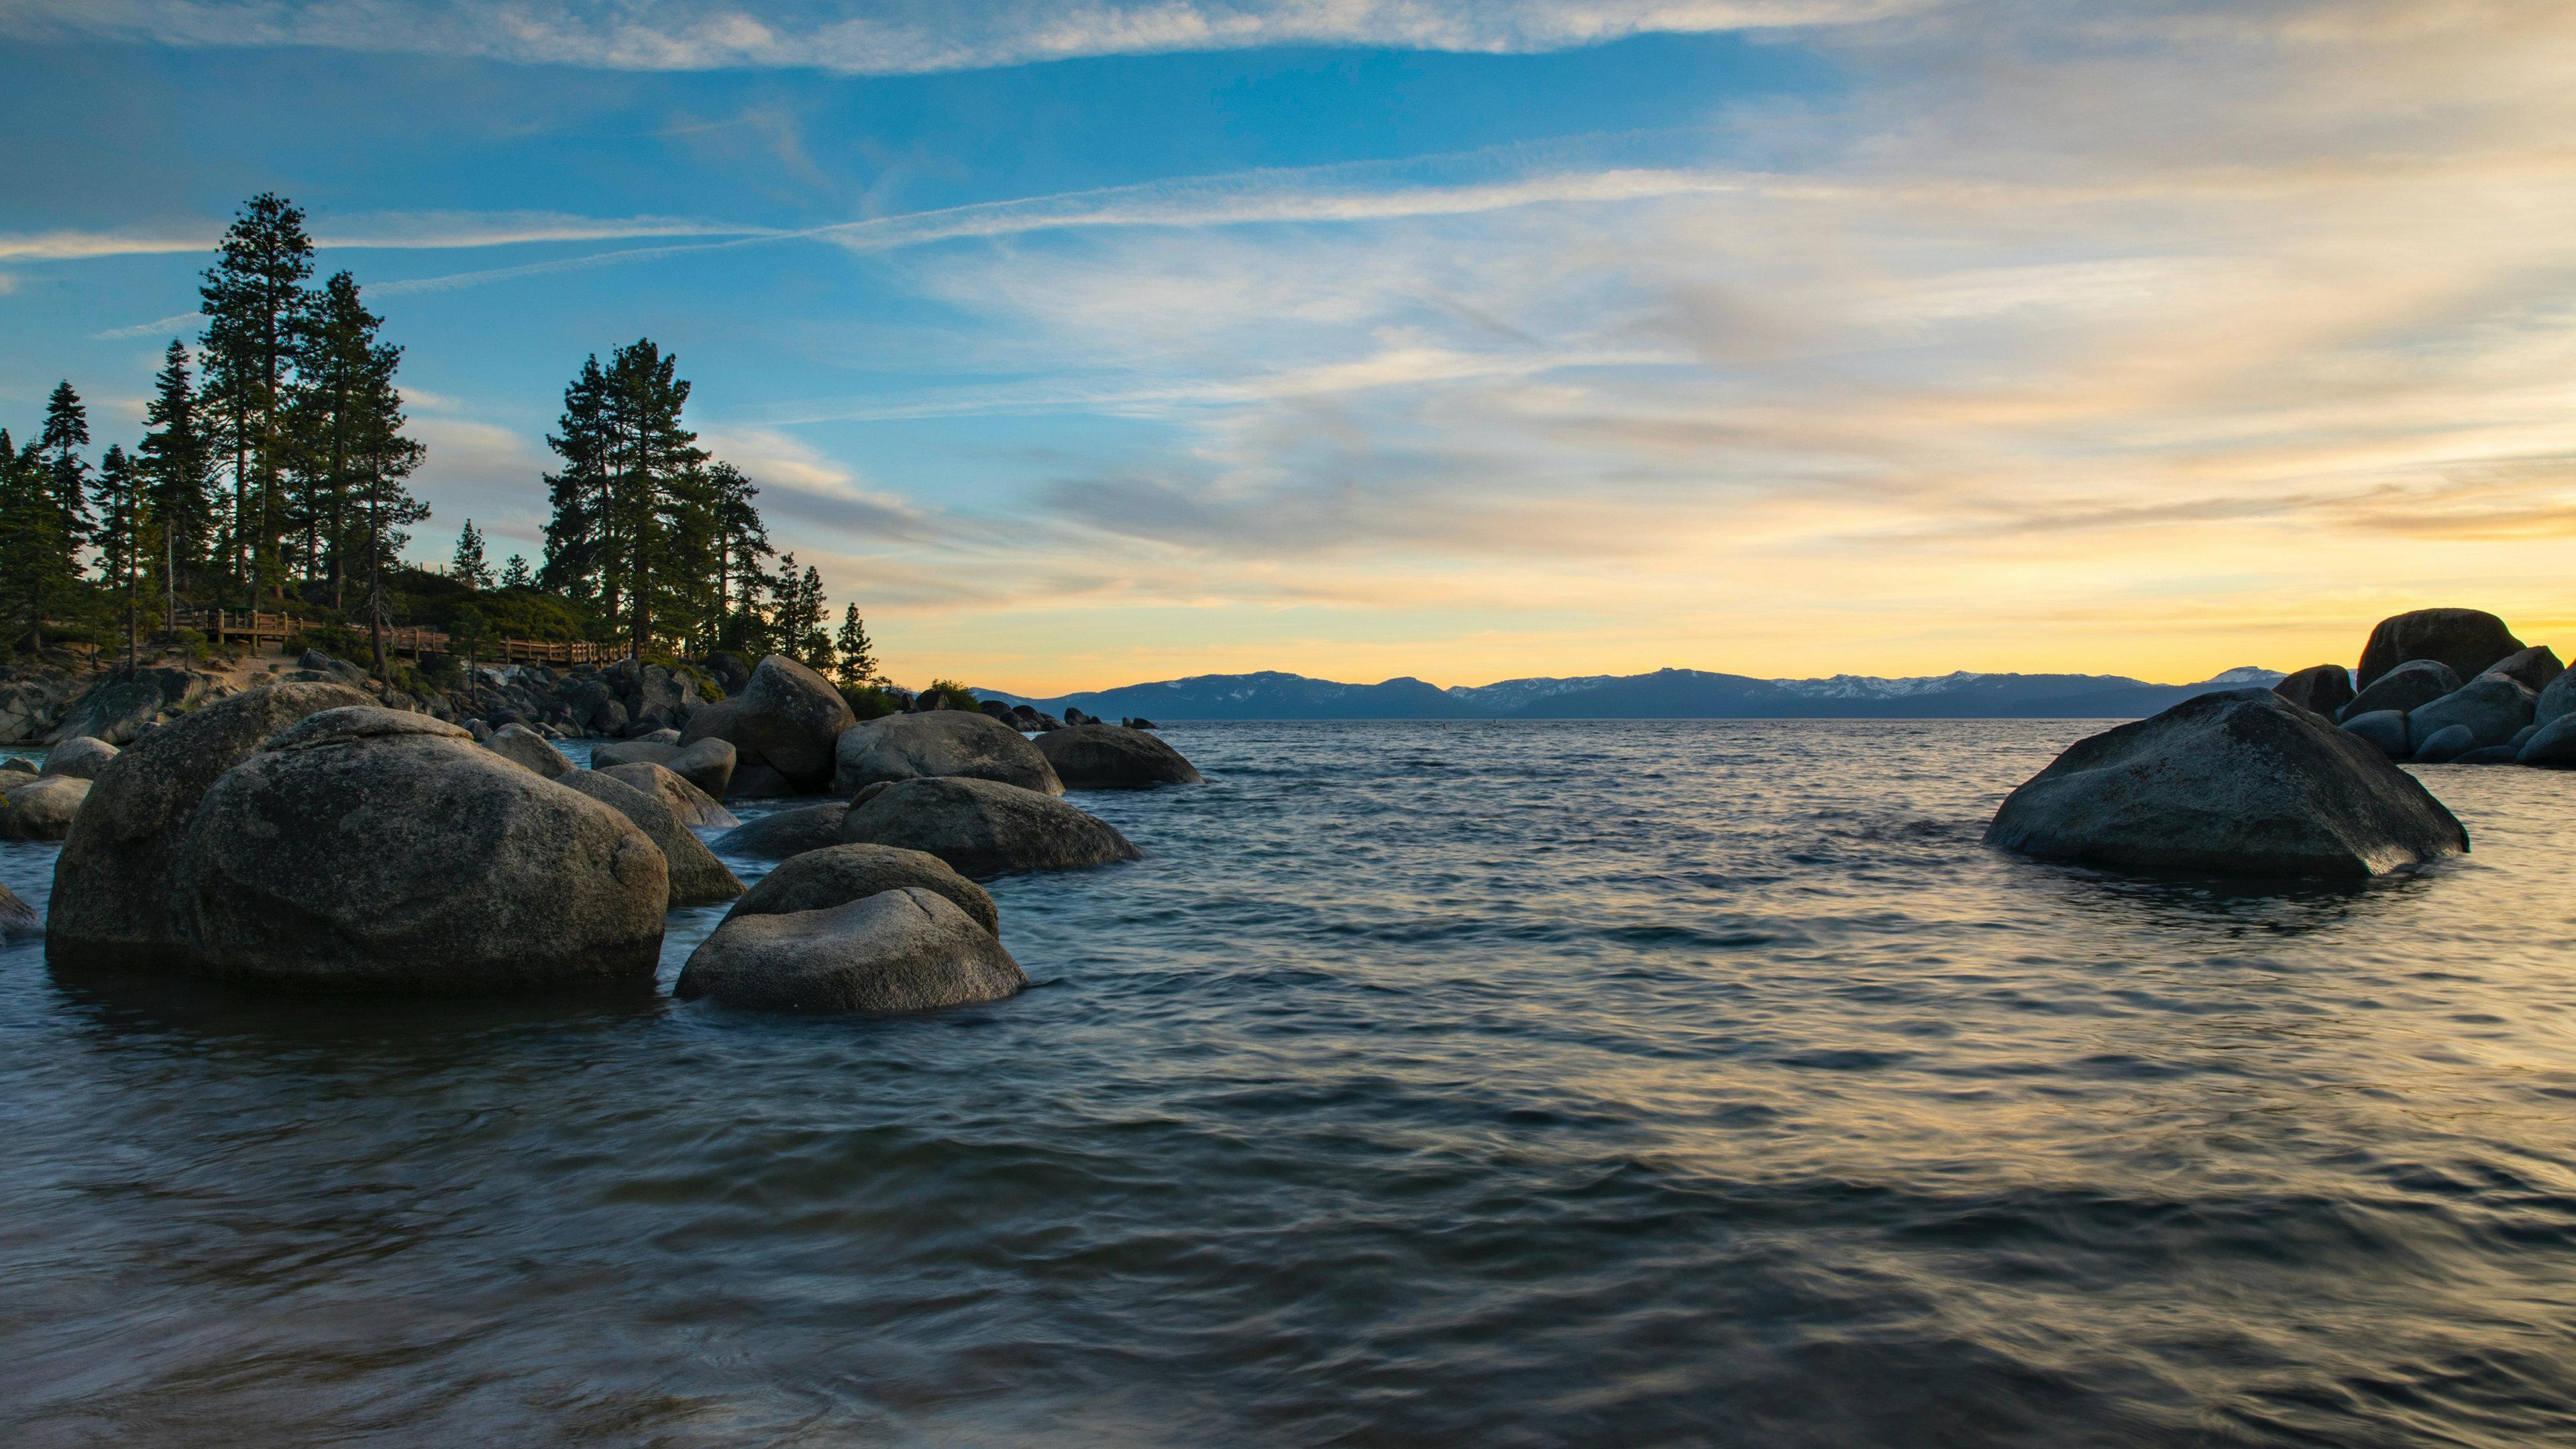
(0, 0, 2576, 696)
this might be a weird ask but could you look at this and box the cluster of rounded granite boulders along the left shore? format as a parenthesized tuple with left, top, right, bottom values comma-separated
(20, 657, 1200, 1011)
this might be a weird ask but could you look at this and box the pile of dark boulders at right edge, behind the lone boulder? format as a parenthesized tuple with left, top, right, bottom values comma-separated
(2272, 608, 2576, 768)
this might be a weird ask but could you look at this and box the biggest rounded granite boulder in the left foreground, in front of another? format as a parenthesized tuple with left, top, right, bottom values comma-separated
(175, 706, 669, 993)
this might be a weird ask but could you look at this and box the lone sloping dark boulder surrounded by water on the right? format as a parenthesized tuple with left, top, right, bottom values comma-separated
(1986, 688, 2468, 877)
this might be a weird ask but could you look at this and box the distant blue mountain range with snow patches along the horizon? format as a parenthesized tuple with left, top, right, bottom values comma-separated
(974, 667, 2282, 722)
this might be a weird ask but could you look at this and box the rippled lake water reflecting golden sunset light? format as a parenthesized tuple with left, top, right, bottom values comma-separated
(0, 722, 2576, 1446)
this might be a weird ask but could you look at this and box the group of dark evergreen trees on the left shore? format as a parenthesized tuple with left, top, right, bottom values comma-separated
(0, 193, 881, 688)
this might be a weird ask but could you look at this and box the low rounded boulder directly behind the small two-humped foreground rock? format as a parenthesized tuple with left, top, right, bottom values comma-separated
(840, 776, 1141, 879)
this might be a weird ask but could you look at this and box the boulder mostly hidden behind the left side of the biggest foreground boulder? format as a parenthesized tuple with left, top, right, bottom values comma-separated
(44, 684, 374, 967)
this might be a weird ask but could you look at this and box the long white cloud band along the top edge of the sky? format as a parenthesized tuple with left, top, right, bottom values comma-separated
(0, 0, 1917, 74)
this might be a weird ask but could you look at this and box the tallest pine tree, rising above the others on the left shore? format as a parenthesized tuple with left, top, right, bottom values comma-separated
(199, 191, 314, 598)
